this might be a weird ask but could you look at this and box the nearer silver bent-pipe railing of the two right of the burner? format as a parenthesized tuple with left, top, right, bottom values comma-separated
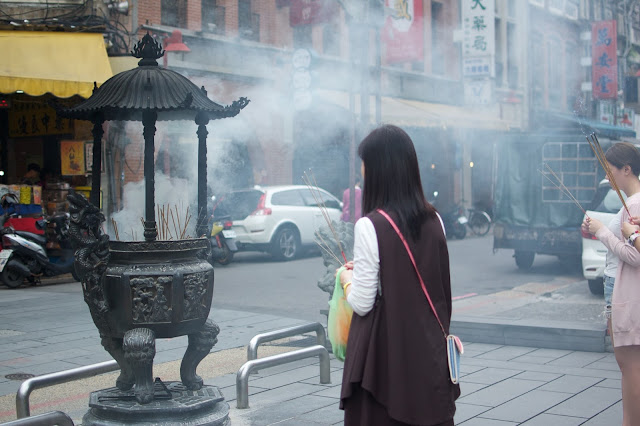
(236, 345, 331, 408)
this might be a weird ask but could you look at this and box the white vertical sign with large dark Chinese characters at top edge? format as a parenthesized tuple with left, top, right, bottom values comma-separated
(462, 0, 496, 57)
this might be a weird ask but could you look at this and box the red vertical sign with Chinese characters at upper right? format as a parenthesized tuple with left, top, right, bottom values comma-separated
(591, 20, 618, 99)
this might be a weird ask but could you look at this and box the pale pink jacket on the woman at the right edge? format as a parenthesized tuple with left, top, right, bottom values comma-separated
(596, 193, 640, 347)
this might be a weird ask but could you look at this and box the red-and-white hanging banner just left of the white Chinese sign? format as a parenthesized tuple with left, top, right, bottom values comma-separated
(381, 0, 424, 63)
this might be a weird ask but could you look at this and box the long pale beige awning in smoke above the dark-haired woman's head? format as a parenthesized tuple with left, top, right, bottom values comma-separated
(314, 90, 512, 130)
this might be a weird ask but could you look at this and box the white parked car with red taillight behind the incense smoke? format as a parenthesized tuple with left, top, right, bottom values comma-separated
(214, 185, 342, 260)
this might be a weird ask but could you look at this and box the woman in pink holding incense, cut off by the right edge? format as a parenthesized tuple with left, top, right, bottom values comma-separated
(582, 142, 640, 426)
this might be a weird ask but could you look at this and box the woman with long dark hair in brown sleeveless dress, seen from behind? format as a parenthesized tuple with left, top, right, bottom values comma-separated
(340, 125, 460, 426)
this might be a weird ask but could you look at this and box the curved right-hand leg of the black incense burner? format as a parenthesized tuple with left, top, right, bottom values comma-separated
(180, 320, 220, 390)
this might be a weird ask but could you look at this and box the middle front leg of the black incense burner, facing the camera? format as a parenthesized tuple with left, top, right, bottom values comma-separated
(122, 328, 156, 404)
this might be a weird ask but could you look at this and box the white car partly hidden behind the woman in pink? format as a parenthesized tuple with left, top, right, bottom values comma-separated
(581, 179, 624, 295)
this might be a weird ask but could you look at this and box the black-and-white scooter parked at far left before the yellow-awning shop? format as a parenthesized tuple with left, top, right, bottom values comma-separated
(0, 194, 76, 288)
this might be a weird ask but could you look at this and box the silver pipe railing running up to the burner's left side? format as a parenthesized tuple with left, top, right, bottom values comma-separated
(16, 360, 120, 419)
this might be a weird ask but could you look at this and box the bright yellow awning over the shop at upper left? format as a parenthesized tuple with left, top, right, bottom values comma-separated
(0, 31, 113, 98)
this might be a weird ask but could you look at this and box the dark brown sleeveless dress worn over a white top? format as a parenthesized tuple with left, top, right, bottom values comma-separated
(340, 212, 460, 426)
